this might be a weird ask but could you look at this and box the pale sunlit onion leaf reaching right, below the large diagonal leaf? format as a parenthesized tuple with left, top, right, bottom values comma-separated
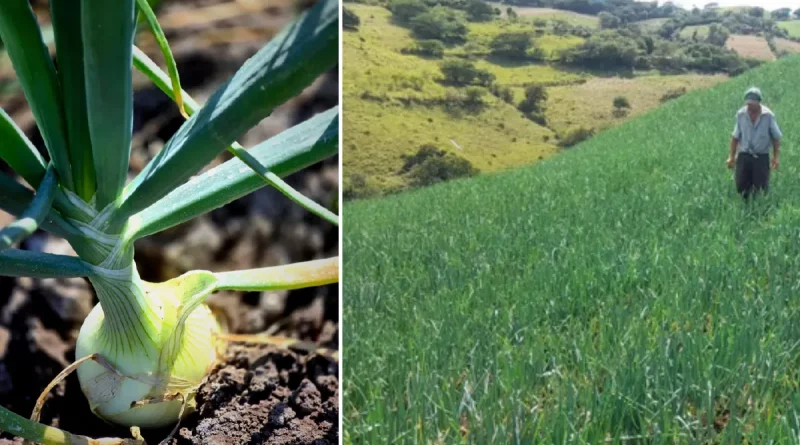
(127, 107, 339, 239)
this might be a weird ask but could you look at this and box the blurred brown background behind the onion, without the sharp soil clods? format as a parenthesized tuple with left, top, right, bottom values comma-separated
(0, 0, 339, 443)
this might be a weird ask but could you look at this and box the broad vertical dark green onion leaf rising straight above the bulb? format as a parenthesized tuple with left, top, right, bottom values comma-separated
(81, 0, 136, 209)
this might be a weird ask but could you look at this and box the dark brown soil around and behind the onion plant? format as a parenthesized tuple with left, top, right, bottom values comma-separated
(0, 0, 339, 445)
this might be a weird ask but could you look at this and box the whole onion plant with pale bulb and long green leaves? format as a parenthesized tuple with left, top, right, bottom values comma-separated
(0, 0, 339, 444)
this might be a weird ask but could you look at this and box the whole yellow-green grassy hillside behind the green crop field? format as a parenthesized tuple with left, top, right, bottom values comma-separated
(342, 4, 724, 192)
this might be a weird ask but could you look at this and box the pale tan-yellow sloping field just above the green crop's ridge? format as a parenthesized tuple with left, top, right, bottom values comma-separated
(547, 74, 727, 134)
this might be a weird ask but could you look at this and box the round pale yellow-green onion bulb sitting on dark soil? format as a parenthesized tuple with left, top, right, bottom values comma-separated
(76, 265, 222, 428)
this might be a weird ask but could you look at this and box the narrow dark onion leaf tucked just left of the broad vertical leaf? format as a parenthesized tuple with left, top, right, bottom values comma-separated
(50, 0, 96, 202)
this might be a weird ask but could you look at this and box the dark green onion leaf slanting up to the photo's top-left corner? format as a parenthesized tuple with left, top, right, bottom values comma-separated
(0, 0, 73, 190)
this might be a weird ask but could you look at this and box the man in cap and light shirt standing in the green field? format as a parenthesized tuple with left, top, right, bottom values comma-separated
(728, 88, 781, 199)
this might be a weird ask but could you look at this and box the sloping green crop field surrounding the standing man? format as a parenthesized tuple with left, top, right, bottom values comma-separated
(343, 56, 800, 444)
